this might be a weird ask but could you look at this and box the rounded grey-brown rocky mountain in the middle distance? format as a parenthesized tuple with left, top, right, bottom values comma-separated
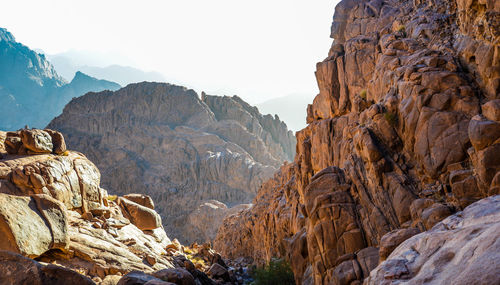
(49, 82, 295, 242)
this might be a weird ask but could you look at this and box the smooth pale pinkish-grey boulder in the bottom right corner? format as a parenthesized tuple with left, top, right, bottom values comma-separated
(365, 195, 500, 285)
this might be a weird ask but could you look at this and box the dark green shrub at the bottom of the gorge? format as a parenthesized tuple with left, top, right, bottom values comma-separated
(252, 259, 295, 285)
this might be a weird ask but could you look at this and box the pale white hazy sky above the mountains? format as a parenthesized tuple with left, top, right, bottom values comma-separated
(0, 0, 338, 103)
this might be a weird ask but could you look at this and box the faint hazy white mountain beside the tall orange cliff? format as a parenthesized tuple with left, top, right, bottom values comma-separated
(256, 94, 311, 131)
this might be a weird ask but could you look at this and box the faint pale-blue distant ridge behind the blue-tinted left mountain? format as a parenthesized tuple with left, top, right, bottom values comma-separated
(47, 53, 166, 86)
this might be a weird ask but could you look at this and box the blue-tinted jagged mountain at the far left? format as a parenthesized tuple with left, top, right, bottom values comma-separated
(0, 28, 120, 130)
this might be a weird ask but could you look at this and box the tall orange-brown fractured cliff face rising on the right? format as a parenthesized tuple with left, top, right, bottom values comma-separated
(215, 0, 500, 284)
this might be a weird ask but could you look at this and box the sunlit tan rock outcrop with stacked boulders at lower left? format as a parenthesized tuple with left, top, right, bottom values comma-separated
(0, 129, 237, 285)
